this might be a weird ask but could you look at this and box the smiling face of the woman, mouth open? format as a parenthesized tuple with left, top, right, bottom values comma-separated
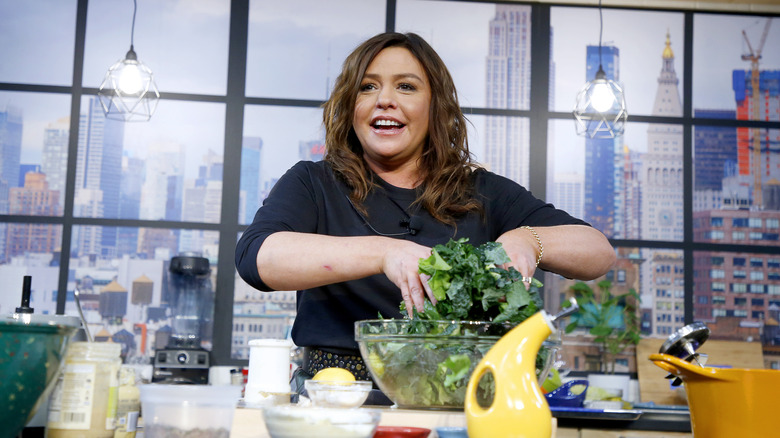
(352, 47, 431, 170)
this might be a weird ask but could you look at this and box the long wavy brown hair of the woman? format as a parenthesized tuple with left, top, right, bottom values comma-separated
(323, 32, 482, 225)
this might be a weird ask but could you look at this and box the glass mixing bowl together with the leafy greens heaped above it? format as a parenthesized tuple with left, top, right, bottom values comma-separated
(355, 239, 557, 410)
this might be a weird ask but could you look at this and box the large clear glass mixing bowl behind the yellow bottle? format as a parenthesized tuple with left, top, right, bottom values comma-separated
(355, 319, 560, 410)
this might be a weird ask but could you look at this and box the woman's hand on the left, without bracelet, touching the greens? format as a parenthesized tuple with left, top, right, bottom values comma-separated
(382, 239, 436, 318)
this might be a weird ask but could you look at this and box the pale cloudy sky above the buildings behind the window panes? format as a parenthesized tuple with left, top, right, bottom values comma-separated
(0, 0, 780, 190)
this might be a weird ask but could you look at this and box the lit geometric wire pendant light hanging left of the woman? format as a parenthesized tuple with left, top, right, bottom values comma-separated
(98, 0, 160, 122)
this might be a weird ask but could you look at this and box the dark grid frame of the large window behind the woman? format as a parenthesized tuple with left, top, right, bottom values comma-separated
(0, 0, 780, 365)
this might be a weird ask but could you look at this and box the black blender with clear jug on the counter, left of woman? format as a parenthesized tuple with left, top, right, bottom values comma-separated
(152, 252, 214, 384)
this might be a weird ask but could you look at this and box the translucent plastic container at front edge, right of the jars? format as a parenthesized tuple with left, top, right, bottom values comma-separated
(139, 383, 241, 438)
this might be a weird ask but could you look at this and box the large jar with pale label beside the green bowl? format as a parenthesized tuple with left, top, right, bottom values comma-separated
(46, 342, 122, 438)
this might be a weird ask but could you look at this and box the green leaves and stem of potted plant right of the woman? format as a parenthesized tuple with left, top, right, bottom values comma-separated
(566, 280, 640, 374)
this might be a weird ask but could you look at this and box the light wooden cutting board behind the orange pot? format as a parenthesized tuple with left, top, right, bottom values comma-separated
(636, 338, 764, 405)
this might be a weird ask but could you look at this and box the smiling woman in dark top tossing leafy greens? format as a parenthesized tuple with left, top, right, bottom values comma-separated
(236, 33, 615, 379)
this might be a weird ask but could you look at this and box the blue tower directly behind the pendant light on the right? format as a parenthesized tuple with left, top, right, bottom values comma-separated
(584, 46, 622, 237)
